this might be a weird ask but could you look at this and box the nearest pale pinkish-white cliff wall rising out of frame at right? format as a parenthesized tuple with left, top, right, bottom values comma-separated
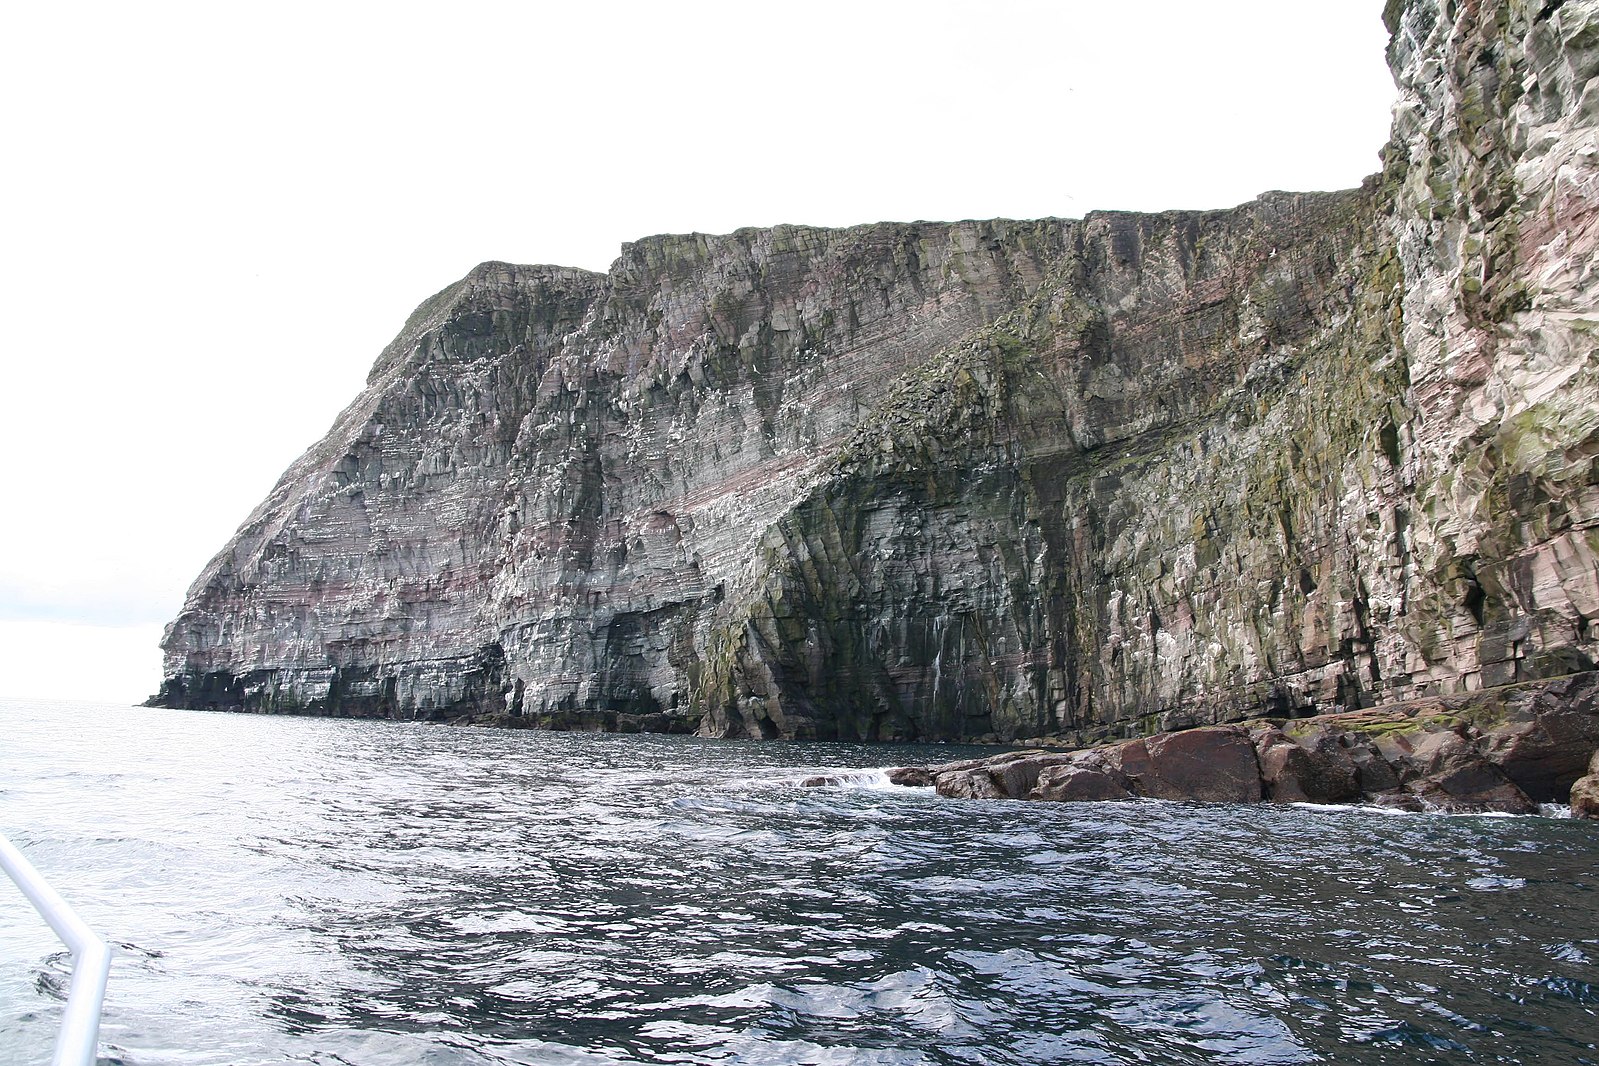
(1382, 0, 1599, 687)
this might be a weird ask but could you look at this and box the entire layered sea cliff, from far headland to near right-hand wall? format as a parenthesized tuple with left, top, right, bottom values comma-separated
(157, 0, 1599, 751)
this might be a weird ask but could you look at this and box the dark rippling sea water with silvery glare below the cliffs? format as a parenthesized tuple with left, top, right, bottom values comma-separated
(0, 700, 1599, 1066)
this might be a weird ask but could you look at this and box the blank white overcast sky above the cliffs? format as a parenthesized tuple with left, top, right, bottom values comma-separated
(0, 0, 1393, 702)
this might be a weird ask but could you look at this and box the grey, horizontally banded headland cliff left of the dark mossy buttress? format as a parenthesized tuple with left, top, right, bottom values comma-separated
(158, 221, 1067, 729)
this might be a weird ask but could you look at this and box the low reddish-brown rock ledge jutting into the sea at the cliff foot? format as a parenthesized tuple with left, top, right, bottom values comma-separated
(876, 671, 1599, 818)
